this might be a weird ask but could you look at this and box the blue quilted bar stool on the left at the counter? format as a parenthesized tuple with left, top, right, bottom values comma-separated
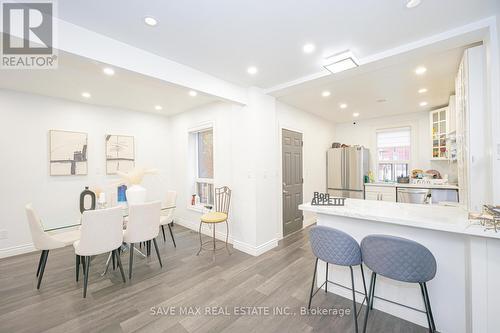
(307, 226, 368, 332)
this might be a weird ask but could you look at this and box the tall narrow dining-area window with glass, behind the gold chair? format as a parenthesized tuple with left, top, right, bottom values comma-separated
(193, 128, 214, 205)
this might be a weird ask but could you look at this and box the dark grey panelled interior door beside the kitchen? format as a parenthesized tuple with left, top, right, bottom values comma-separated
(281, 129, 304, 236)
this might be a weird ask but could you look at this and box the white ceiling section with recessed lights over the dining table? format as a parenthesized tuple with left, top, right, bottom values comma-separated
(0, 52, 219, 115)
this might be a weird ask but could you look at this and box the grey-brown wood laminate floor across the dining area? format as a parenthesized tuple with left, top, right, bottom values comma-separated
(0, 225, 426, 333)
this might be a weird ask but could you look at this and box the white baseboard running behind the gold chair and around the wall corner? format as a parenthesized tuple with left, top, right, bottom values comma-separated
(175, 217, 278, 256)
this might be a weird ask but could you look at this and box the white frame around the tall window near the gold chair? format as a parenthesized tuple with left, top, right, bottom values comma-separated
(189, 122, 215, 211)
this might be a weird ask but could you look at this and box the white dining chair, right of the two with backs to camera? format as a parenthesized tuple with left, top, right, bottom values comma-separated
(123, 201, 163, 279)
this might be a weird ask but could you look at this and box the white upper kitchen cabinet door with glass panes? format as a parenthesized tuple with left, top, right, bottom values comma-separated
(430, 107, 449, 160)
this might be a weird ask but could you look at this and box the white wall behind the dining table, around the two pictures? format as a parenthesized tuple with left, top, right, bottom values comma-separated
(0, 90, 172, 256)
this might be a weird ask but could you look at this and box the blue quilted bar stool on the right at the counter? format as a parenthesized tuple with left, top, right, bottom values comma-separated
(361, 235, 437, 332)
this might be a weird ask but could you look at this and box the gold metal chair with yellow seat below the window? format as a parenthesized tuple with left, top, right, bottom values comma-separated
(196, 186, 231, 261)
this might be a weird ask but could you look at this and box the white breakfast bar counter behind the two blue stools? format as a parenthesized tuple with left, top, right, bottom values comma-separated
(299, 198, 500, 333)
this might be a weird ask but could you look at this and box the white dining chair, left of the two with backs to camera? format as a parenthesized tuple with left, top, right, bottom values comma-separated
(73, 207, 125, 298)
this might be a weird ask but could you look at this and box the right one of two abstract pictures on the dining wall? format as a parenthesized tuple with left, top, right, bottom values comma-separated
(106, 134, 135, 175)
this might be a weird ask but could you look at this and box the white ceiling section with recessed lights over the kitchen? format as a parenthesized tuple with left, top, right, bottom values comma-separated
(273, 43, 465, 123)
